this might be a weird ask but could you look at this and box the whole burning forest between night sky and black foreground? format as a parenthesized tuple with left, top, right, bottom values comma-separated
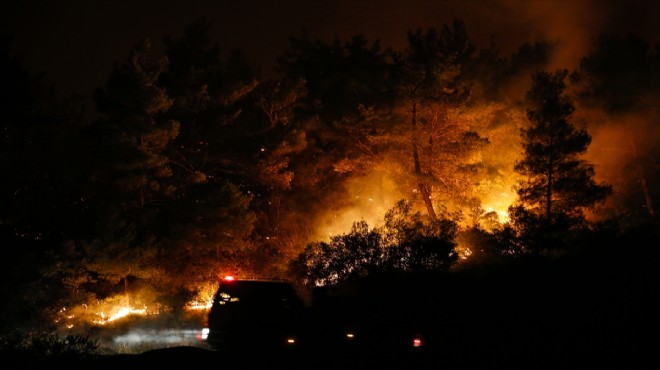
(0, 19, 660, 336)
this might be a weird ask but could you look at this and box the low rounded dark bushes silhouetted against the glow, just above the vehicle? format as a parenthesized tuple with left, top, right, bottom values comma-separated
(290, 201, 458, 286)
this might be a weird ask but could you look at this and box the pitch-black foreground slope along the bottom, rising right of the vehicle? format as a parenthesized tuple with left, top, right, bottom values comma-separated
(0, 253, 660, 370)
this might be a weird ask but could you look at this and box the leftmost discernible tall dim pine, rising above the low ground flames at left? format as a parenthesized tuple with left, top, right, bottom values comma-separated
(71, 40, 179, 302)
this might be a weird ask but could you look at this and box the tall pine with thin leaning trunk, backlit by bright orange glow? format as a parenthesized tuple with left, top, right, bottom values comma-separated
(393, 23, 486, 218)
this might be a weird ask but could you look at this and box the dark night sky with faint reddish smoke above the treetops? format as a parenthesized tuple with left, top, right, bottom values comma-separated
(0, 0, 660, 95)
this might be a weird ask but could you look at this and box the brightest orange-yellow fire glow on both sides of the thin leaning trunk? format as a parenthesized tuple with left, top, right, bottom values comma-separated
(312, 103, 527, 246)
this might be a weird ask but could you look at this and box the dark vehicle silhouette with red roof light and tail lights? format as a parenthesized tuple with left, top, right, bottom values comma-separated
(205, 278, 428, 357)
